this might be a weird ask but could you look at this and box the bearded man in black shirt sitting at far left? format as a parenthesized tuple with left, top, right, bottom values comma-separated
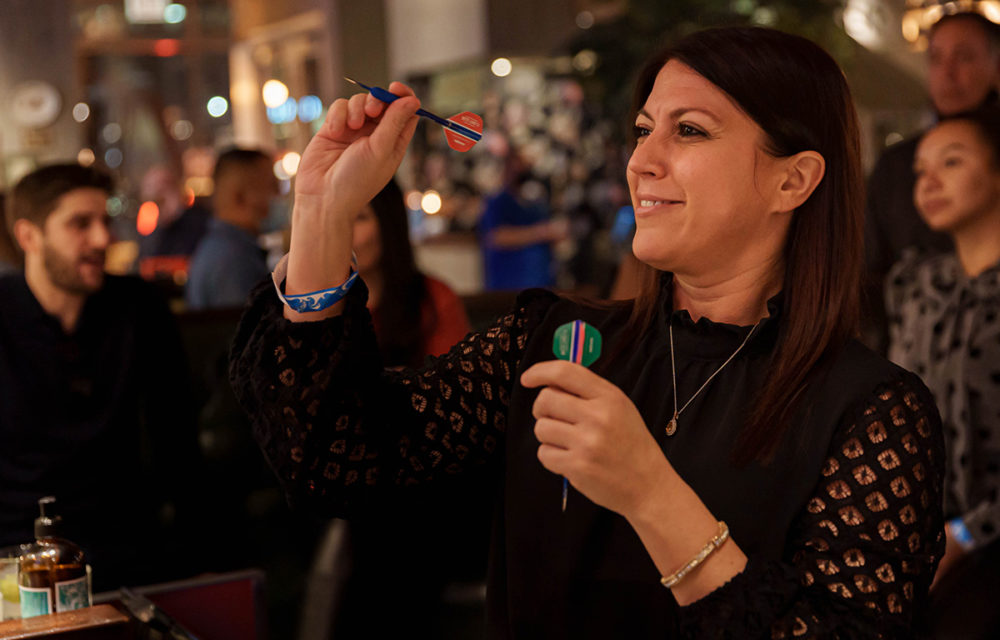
(0, 164, 199, 591)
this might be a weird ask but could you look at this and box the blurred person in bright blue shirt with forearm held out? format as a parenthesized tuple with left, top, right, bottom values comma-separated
(478, 151, 568, 291)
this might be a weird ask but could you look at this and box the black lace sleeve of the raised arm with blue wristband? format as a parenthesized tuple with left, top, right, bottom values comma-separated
(230, 278, 556, 515)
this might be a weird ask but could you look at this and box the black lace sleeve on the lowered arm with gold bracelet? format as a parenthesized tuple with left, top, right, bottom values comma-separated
(682, 374, 944, 639)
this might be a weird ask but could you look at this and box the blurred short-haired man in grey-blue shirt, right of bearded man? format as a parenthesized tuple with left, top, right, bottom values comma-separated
(184, 149, 278, 310)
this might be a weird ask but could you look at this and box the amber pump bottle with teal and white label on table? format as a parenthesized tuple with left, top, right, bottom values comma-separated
(18, 496, 90, 618)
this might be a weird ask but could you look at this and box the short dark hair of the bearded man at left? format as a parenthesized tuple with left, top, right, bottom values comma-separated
(7, 164, 114, 233)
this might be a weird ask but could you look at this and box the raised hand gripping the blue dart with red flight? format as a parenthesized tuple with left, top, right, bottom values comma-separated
(295, 82, 420, 220)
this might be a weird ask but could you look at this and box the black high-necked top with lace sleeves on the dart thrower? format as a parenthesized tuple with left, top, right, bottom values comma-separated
(231, 278, 943, 638)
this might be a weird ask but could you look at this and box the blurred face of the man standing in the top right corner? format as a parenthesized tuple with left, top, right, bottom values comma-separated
(927, 19, 1000, 116)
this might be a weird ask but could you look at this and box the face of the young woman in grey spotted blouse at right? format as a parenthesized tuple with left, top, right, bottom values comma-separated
(914, 120, 1000, 233)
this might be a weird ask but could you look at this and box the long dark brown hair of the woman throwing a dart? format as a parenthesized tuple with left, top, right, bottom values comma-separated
(625, 27, 863, 462)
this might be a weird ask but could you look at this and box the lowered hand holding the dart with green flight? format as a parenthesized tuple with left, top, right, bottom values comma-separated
(521, 360, 677, 517)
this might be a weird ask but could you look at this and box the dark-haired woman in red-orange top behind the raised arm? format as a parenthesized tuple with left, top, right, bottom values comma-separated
(353, 180, 470, 367)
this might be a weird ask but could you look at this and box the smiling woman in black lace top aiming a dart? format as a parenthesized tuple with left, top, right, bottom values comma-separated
(232, 28, 942, 638)
